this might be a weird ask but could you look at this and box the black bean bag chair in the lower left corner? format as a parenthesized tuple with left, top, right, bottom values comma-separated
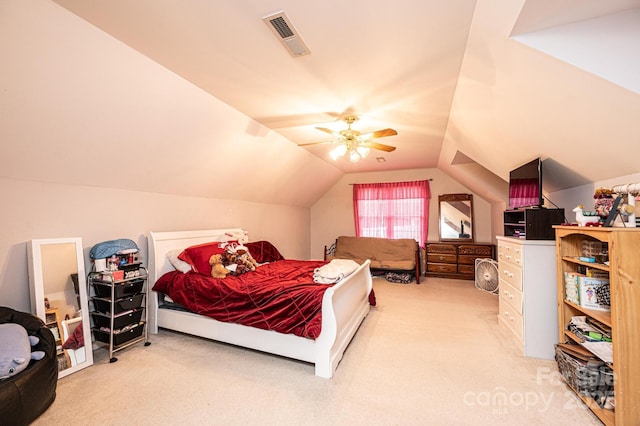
(0, 306, 58, 426)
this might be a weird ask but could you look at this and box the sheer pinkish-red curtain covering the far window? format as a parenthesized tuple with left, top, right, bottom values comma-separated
(353, 180, 431, 247)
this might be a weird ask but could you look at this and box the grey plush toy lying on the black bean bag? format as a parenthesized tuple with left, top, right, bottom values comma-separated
(0, 323, 45, 380)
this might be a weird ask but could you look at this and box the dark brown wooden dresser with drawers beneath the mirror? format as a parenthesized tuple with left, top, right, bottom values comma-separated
(425, 242, 495, 280)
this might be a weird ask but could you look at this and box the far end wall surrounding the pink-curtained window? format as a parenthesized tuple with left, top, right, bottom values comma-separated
(311, 169, 495, 259)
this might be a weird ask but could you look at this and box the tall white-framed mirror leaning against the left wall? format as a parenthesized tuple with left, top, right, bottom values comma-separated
(28, 238, 93, 379)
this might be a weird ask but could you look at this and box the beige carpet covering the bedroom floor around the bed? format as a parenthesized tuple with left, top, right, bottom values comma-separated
(35, 278, 600, 426)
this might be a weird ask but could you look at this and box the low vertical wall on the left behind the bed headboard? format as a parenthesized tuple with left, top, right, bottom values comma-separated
(0, 178, 310, 311)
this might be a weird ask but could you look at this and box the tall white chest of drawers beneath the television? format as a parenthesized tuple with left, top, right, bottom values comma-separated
(496, 236, 558, 359)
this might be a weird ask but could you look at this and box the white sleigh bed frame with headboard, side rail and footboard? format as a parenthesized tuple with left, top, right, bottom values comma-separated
(148, 228, 372, 378)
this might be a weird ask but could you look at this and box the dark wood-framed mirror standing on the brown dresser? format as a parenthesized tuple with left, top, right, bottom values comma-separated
(438, 194, 475, 242)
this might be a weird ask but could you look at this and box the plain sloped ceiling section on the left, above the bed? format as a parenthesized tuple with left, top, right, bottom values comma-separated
(0, 1, 341, 206)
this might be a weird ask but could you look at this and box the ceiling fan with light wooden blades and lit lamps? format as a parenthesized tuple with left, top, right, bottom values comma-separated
(298, 115, 398, 163)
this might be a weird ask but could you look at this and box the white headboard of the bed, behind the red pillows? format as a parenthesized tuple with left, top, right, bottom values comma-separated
(147, 228, 245, 287)
